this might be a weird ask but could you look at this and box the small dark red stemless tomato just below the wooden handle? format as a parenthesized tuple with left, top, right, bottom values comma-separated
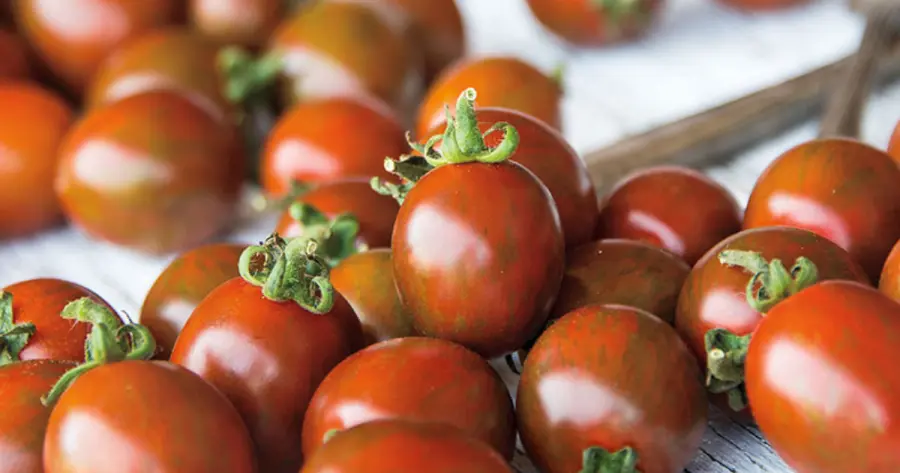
(595, 166, 741, 265)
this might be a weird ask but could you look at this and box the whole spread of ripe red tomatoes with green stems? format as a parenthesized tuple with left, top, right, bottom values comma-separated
(0, 0, 900, 473)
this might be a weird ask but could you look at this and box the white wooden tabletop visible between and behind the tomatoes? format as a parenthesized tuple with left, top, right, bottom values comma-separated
(0, 0, 900, 473)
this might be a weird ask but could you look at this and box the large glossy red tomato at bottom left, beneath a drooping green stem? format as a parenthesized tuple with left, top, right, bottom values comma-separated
(44, 361, 257, 473)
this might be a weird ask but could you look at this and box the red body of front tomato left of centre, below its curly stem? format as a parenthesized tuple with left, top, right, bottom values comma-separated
(171, 278, 362, 473)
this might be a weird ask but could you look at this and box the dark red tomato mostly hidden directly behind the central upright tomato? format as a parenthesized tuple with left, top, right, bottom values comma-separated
(427, 107, 600, 248)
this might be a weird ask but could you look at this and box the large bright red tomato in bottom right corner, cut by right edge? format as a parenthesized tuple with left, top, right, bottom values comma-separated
(745, 281, 900, 473)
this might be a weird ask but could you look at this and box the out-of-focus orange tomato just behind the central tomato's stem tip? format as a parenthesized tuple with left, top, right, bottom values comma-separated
(416, 57, 562, 140)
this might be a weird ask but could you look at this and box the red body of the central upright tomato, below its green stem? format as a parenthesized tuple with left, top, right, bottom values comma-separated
(391, 162, 565, 357)
